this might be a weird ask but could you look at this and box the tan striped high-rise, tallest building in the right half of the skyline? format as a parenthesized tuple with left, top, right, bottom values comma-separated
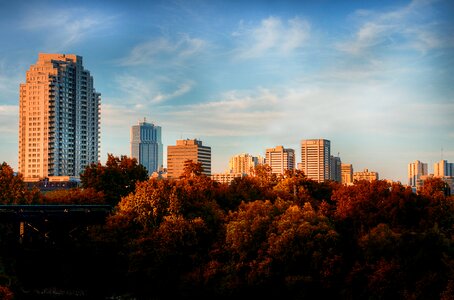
(300, 139, 331, 182)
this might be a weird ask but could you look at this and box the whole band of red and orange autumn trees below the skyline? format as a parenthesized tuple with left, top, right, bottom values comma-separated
(0, 155, 454, 300)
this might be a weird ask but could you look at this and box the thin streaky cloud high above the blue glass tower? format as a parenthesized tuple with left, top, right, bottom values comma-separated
(120, 34, 208, 66)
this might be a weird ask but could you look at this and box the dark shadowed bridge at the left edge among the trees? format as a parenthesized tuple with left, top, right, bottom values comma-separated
(0, 205, 112, 243)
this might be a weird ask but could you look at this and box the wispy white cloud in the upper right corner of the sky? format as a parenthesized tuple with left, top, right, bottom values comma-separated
(336, 1, 454, 55)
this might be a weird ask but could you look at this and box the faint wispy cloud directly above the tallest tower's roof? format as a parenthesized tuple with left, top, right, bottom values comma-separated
(22, 7, 115, 49)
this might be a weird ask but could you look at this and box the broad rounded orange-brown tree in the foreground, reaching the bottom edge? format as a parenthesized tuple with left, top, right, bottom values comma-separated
(206, 199, 340, 298)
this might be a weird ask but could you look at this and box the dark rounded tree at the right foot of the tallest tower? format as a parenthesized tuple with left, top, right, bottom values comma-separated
(80, 154, 148, 205)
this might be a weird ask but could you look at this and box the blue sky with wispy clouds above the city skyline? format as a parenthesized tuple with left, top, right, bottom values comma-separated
(0, 0, 454, 183)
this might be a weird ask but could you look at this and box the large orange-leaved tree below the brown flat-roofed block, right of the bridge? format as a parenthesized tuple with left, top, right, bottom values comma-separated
(101, 164, 223, 297)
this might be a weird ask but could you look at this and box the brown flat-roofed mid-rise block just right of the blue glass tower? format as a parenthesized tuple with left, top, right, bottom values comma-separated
(167, 139, 211, 178)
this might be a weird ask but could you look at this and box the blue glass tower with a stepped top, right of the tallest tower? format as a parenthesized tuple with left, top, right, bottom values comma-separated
(131, 119, 163, 176)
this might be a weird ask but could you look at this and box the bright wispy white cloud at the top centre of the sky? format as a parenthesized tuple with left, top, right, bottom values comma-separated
(232, 17, 311, 59)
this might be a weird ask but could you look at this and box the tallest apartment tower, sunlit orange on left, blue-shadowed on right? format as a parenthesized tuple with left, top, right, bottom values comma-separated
(19, 53, 101, 181)
